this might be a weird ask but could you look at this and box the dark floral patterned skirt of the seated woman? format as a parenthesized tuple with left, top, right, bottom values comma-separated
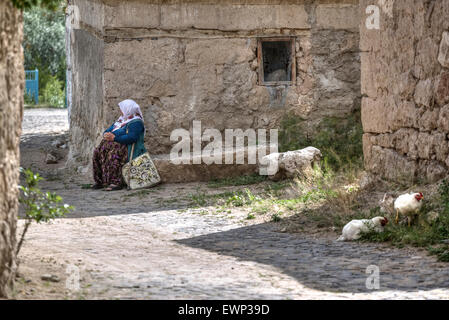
(93, 140, 128, 186)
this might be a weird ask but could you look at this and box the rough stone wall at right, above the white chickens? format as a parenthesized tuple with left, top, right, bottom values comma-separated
(360, 0, 449, 182)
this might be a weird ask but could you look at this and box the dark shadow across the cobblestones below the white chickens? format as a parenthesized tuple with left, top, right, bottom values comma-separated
(177, 223, 449, 292)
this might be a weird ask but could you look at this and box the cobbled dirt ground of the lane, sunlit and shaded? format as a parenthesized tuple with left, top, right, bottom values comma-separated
(14, 109, 449, 299)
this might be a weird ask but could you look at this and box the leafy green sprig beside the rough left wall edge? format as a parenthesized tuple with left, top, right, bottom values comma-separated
(19, 168, 73, 223)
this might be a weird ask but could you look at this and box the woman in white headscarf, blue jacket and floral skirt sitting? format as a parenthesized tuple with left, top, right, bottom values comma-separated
(93, 100, 146, 191)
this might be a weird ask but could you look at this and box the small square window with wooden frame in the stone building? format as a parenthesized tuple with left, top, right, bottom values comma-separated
(257, 38, 296, 86)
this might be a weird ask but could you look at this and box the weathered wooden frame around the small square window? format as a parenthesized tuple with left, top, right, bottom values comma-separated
(257, 37, 296, 86)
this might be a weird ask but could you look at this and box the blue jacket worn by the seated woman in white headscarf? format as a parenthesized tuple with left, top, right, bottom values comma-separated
(103, 119, 147, 161)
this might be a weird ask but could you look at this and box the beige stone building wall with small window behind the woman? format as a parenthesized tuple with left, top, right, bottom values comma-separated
(67, 0, 360, 181)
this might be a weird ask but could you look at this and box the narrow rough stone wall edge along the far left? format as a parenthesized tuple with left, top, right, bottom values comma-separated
(0, 1, 25, 298)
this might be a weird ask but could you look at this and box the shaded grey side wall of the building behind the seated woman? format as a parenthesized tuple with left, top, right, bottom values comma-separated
(66, 0, 105, 163)
